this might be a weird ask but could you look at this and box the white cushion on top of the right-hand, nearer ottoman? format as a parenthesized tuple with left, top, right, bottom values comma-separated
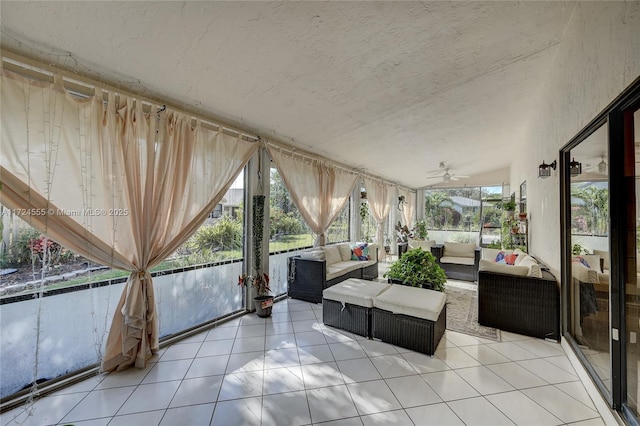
(373, 284, 447, 322)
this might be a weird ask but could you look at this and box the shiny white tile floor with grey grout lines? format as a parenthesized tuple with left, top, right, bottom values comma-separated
(0, 299, 605, 426)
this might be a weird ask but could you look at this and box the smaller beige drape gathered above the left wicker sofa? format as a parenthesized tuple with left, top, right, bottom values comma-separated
(267, 145, 358, 246)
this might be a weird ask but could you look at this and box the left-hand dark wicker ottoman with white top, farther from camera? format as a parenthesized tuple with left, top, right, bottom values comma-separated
(322, 278, 391, 338)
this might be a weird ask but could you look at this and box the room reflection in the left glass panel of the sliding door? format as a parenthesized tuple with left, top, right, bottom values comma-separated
(570, 125, 611, 391)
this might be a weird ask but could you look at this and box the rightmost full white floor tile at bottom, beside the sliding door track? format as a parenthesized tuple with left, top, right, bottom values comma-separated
(521, 386, 599, 423)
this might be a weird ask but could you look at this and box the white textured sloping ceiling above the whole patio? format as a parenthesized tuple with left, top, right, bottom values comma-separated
(1, 1, 574, 188)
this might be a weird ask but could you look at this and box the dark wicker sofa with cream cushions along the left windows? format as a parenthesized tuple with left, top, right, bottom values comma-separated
(287, 243, 378, 303)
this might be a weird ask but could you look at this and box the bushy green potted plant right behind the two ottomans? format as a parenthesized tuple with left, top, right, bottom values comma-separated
(383, 247, 447, 291)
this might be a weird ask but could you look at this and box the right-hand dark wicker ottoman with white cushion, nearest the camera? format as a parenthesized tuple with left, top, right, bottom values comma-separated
(372, 285, 447, 355)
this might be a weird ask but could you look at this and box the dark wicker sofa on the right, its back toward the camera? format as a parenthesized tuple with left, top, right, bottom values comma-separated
(478, 249, 560, 342)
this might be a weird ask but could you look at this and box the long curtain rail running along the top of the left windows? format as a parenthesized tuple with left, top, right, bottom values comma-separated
(0, 47, 415, 191)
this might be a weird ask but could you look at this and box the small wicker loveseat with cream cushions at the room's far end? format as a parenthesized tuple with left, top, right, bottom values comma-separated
(431, 242, 481, 281)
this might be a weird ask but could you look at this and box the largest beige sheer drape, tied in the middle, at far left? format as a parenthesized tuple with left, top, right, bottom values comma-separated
(0, 70, 257, 371)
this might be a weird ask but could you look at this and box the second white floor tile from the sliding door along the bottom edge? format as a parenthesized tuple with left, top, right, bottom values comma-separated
(486, 391, 562, 426)
